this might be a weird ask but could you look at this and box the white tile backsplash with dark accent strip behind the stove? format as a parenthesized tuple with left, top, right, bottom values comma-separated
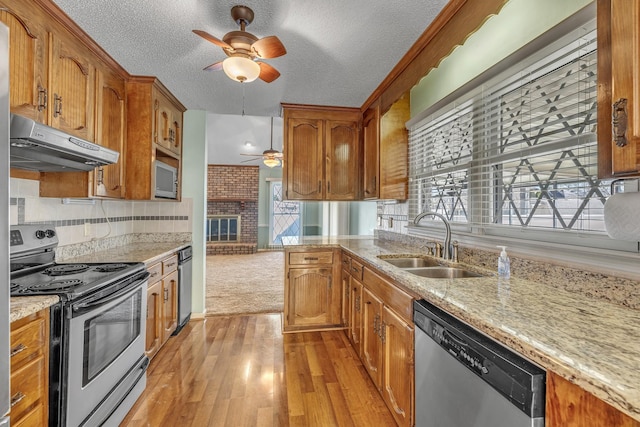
(9, 178, 193, 246)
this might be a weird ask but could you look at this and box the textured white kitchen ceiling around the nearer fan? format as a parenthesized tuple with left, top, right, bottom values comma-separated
(54, 0, 447, 116)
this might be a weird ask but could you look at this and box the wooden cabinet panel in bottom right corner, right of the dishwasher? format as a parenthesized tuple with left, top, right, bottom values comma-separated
(545, 371, 640, 427)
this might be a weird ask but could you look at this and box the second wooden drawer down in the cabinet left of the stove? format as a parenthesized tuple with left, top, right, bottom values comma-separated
(11, 356, 47, 420)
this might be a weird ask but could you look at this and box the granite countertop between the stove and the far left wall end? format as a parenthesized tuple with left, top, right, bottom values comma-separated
(64, 242, 191, 266)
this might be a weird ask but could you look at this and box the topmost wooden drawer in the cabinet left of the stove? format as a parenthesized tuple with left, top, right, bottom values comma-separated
(9, 314, 49, 370)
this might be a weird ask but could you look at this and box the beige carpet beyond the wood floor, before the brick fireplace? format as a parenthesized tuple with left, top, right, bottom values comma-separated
(205, 251, 284, 316)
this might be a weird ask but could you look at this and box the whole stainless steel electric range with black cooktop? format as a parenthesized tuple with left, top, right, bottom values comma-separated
(10, 225, 149, 427)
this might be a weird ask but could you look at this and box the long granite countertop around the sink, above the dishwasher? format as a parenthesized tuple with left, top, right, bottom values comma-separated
(287, 237, 640, 421)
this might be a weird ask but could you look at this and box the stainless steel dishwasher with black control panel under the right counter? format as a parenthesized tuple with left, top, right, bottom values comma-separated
(413, 300, 546, 427)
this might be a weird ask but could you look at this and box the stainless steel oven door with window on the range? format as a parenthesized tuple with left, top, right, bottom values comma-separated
(63, 276, 147, 426)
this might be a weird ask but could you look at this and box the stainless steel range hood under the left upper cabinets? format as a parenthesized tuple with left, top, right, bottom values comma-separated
(9, 114, 120, 172)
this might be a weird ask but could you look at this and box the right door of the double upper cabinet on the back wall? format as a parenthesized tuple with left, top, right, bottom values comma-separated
(325, 120, 360, 200)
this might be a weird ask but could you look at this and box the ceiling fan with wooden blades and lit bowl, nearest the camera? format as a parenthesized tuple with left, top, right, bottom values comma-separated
(193, 6, 287, 83)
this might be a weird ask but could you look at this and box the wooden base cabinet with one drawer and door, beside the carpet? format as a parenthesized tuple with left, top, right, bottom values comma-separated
(283, 248, 344, 332)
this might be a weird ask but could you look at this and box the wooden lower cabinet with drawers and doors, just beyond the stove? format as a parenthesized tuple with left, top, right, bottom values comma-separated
(145, 255, 178, 359)
